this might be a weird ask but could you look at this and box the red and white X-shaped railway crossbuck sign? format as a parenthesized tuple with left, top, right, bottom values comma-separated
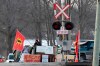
(54, 3, 70, 19)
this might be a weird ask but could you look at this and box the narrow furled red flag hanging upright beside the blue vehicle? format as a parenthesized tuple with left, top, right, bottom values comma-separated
(75, 30, 80, 62)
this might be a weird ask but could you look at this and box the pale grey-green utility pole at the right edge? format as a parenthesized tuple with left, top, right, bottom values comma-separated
(92, 0, 100, 66)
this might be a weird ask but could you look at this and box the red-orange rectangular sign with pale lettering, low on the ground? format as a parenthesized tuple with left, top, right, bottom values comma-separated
(24, 55, 41, 62)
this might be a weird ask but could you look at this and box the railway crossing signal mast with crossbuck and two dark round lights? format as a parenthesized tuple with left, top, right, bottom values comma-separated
(52, 0, 74, 60)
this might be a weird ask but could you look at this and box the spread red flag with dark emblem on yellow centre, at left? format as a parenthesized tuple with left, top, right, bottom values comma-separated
(13, 30, 25, 51)
